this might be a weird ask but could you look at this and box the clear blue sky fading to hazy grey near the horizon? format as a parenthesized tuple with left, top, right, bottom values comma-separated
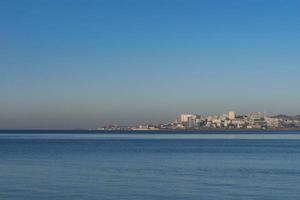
(0, 0, 300, 129)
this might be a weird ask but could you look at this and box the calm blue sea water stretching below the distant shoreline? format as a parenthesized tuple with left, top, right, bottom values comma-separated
(0, 131, 300, 200)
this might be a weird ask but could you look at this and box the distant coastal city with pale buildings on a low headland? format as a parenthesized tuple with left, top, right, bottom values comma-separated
(97, 111, 300, 131)
